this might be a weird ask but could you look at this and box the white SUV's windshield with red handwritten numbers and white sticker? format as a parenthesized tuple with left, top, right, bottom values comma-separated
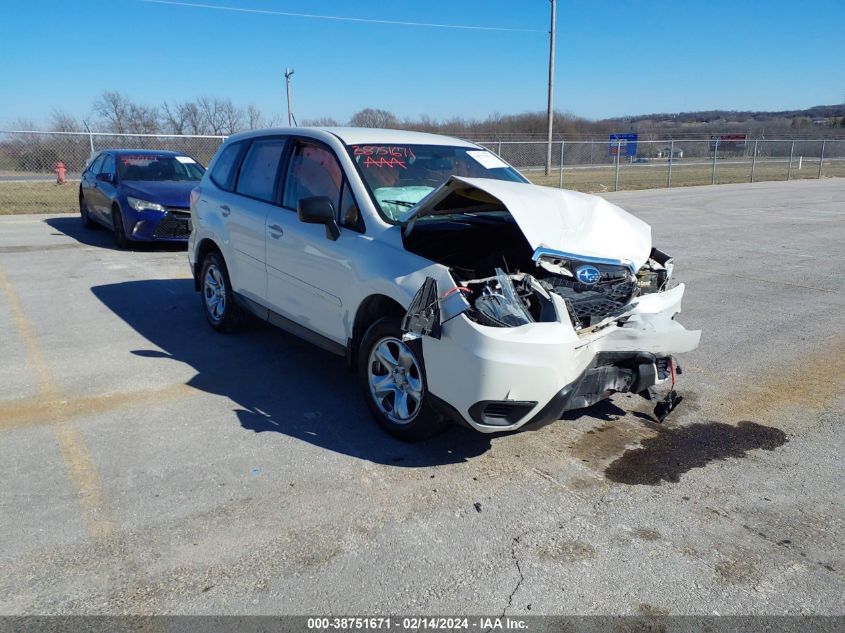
(349, 145, 528, 222)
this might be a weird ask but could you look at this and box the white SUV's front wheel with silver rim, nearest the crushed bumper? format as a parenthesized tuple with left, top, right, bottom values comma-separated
(358, 317, 446, 442)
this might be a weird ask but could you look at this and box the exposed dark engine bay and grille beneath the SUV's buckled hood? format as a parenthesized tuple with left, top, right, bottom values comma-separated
(405, 211, 672, 330)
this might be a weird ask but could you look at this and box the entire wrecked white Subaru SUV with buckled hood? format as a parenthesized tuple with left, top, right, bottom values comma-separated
(188, 128, 700, 440)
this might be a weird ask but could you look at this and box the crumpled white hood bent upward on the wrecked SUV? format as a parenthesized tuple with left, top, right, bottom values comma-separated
(401, 176, 651, 271)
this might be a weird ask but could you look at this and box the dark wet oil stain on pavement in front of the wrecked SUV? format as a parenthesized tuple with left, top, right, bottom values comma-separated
(604, 421, 787, 486)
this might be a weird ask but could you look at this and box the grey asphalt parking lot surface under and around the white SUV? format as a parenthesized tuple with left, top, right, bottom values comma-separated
(0, 179, 845, 615)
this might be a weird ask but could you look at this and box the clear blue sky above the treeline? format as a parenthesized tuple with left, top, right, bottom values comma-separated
(0, 0, 845, 128)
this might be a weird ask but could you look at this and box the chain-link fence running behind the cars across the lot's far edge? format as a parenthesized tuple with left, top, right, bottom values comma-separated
(0, 131, 845, 214)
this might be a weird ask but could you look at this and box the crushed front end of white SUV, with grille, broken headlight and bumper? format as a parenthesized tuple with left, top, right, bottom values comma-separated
(404, 250, 700, 432)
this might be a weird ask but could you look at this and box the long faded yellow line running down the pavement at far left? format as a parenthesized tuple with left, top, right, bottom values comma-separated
(0, 267, 114, 540)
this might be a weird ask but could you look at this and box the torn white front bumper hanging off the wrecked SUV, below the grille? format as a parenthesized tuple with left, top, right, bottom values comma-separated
(422, 284, 701, 433)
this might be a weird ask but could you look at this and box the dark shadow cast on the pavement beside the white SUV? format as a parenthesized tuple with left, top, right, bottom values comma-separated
(92, 279, 491, 467)
